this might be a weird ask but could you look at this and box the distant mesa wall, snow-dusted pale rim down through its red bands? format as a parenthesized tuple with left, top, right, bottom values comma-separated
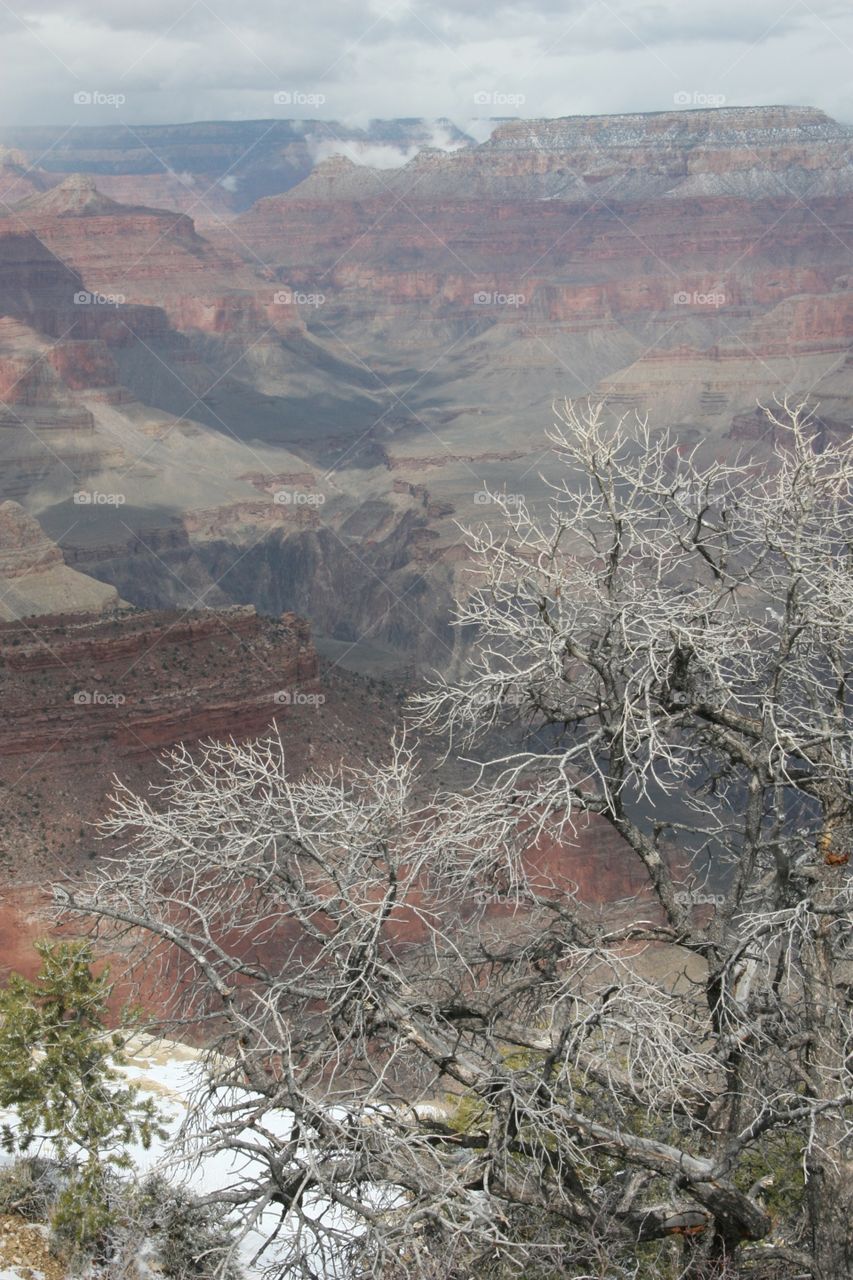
(237, 108, 853, 358)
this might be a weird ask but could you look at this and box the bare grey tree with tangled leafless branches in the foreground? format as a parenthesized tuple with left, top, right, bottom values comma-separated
(64, 404, 853, 1280)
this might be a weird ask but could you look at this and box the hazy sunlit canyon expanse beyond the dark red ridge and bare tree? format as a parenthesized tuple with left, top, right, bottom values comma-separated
(0, 106, 853, 673)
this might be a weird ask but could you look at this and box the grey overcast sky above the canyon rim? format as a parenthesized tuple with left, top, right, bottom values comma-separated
(0, 0, 853, 127)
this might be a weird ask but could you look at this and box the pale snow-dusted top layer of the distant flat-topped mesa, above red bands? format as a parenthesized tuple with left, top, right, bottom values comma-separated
(240, 106, 853, 209)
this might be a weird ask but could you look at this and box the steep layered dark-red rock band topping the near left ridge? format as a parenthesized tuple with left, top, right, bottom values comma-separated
(0, 608, 319, 752)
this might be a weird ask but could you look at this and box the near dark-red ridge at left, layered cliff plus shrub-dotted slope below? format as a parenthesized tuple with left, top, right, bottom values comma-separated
(0, 608, 396, 884)
